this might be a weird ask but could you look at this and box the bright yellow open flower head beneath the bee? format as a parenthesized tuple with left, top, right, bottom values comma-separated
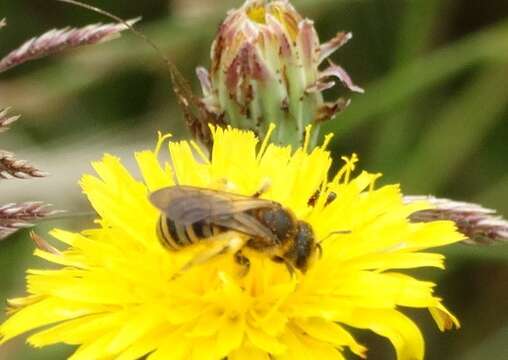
(0, 129, 462, 360)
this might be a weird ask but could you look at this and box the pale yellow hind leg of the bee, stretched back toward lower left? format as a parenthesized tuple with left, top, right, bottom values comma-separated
(173, 231, 245, 279)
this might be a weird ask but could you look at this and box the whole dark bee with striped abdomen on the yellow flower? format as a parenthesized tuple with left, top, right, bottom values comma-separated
(150, 185, 320, 274)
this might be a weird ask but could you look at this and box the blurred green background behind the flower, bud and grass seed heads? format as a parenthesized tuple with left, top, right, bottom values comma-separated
(0, 0, 508, 360)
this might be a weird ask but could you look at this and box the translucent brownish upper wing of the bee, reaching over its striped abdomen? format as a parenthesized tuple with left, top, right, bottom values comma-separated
(150, 186, 274, 226)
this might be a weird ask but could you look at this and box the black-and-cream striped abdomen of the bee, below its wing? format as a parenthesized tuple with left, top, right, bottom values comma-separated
(157, 216, 216, 251)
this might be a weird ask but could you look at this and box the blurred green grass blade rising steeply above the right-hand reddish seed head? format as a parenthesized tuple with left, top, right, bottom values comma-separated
(400, 63, 508, 193)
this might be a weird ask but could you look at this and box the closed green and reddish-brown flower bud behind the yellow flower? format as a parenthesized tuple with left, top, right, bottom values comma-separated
(197, 0, 363, 146)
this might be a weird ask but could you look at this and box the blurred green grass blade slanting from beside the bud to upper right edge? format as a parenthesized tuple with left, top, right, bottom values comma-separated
(335, 20, 508, 137)
